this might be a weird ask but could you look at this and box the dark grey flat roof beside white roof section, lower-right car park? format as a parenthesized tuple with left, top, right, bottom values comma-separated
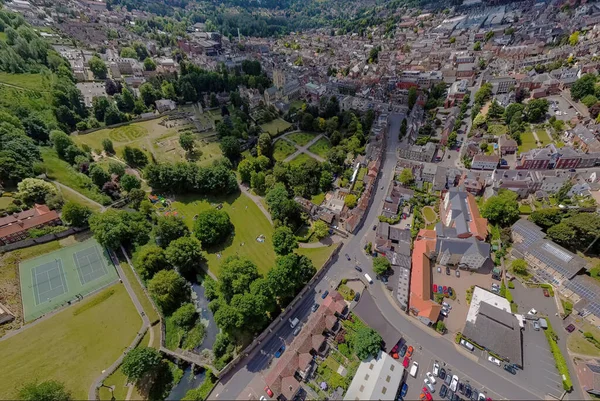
(463, 302, 523, 366)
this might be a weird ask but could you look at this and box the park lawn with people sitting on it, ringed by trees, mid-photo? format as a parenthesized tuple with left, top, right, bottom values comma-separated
(166, 193, 275, 277)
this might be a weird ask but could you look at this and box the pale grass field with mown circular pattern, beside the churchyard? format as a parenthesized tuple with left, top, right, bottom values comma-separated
(73, 114, 222, 164)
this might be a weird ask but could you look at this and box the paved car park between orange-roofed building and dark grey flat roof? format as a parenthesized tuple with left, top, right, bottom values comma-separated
(433, 266, 498, 333)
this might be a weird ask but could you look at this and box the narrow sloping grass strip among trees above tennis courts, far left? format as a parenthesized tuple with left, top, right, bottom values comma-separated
(40, 147, 111, 205)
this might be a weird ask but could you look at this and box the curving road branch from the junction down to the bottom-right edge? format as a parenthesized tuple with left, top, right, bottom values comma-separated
(371, 284, 540, 400)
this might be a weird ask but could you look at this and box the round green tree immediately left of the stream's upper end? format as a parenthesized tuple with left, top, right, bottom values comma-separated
(148, 270, 189, 314)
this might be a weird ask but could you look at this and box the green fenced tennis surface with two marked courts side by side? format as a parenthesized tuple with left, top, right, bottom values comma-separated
(19, 239, 119, 322)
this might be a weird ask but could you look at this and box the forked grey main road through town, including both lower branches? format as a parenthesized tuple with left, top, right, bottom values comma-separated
(209, 114, 543, 400)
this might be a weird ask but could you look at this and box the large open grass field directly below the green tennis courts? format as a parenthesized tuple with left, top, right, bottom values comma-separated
(0, 284, 142, 399)
